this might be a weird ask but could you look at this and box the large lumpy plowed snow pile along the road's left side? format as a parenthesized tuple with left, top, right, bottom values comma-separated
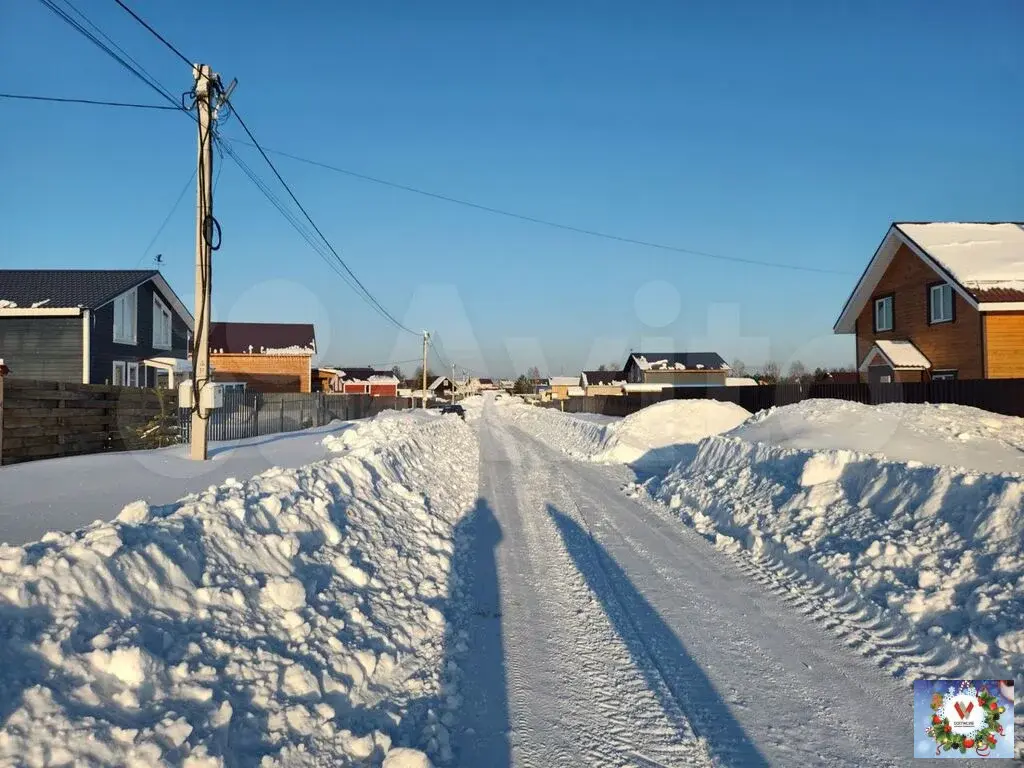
(0, 419, 478, 768)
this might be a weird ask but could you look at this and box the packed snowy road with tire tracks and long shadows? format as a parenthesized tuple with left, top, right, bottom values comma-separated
(464, 402, 913, 766)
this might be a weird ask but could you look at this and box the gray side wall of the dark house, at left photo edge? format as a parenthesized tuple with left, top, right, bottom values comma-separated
(0, 316, 82, 383)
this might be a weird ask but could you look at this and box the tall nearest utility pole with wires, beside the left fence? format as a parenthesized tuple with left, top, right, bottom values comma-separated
(190, 65, 214, 461)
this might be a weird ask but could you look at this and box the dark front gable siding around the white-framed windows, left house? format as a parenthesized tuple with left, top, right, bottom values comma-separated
(91, 281, 188, 386)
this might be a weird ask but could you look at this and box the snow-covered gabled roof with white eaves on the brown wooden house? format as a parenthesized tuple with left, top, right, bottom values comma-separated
(833, 221, 1024, 333)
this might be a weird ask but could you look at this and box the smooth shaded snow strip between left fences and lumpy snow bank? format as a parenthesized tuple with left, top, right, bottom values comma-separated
(0, 421, 368, 545)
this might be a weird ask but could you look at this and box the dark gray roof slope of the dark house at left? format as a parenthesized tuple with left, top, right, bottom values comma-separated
(0, 269, 160, 309)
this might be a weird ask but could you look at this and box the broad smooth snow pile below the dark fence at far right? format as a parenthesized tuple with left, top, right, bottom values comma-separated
(730, 399, 1024, 472)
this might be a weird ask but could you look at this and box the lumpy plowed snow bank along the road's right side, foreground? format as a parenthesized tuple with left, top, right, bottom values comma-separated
(650, 436, 1024, 684)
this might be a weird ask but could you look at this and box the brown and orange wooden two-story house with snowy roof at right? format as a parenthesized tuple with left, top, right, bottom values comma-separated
(834, 222, 1024, 383)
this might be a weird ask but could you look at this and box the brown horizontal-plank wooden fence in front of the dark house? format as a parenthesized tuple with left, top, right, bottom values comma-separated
(0, 378, 163, 464)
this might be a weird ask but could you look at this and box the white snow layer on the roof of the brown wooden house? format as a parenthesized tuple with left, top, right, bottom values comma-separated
(897, 222, 1024, 290)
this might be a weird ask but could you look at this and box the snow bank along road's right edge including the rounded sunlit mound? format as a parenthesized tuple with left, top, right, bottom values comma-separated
(502, 400, 750, 467)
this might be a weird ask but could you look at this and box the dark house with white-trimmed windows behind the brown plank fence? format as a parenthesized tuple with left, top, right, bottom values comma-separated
(0, 269, 194, 387)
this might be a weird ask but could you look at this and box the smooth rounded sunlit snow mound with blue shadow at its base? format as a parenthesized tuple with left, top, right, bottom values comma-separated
(594, 400, 751, 466)
